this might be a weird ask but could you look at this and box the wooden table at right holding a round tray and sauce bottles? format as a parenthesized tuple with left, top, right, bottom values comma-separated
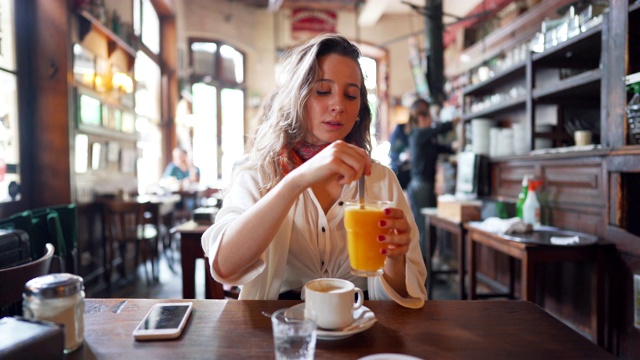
(465, 223, 606, 344)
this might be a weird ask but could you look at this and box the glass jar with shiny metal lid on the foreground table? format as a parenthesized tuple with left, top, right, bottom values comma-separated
(22, 273, 84, 353)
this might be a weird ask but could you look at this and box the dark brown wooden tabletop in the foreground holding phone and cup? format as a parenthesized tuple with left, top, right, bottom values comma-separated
(67, 299, 614, 360)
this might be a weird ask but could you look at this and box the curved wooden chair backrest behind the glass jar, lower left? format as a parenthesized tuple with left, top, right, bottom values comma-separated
(0, 244, 55, 307)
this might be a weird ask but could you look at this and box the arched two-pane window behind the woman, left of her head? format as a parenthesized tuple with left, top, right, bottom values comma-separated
(189, 39, 245, 186)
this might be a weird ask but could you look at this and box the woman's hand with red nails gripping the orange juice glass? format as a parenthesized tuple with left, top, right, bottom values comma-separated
(378, 208, 411, 259)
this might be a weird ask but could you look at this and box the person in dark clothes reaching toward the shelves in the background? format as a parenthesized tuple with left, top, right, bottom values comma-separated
(407, 99, 460, 256)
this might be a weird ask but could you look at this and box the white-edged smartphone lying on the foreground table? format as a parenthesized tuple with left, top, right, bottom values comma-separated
(133, 302, 193, 340)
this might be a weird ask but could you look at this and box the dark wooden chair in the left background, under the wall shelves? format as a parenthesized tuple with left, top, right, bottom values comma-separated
(103, 199, 158, 286)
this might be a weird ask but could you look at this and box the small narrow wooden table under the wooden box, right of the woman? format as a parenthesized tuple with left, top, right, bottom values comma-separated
(421, 208, 467, 300)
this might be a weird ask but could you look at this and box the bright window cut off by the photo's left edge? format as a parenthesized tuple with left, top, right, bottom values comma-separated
(0, 0, 20, 202)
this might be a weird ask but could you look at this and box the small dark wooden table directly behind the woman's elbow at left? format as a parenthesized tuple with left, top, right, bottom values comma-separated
(175, 220, 224, 299)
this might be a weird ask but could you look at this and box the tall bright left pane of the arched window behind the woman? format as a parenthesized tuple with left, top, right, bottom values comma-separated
(191, 83, 218, 186)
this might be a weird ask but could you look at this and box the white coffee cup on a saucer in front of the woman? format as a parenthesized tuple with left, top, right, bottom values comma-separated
(302, 278, 364, 329)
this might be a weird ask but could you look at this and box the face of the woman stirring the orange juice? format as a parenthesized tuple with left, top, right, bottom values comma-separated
(305, 54, 362, 145)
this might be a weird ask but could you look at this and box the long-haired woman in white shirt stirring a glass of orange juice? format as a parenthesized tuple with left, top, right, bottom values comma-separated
(202, 35, 426, 308)
